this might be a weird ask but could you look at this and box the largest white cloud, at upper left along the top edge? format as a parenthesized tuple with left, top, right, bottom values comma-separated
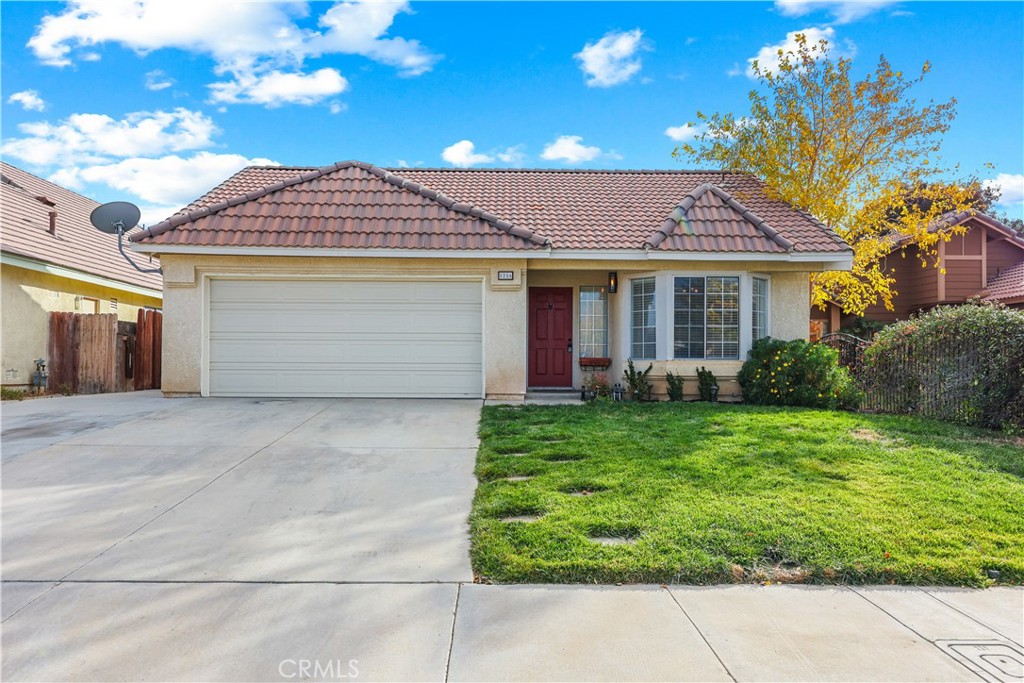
(29, 0, 440, 106)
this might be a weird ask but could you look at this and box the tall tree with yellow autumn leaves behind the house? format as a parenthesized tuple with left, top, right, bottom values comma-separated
(673, 34, 980, 314)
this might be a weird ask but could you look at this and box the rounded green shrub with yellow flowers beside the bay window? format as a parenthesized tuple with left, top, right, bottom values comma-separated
(737, 337, 859, 408)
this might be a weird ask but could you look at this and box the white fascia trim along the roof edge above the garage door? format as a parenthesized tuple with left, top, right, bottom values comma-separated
(131, 244, 550, 259)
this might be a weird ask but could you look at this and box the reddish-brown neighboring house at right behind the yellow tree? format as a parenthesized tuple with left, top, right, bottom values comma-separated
(811, 212, 1024, 338)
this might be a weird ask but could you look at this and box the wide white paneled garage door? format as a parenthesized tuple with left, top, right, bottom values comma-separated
(210, 280, 483, 398)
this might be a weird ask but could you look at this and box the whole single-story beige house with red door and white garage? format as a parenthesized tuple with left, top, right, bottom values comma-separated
(125, 162, 852, 400)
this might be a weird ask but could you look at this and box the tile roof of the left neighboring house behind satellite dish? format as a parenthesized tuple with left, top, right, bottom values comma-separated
(0, 162, 163, 293)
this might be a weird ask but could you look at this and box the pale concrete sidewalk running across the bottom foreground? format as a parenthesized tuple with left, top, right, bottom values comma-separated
(3, 582, 1024, 682)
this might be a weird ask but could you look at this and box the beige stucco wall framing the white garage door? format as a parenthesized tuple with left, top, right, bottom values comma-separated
(161, 254, 526, 400)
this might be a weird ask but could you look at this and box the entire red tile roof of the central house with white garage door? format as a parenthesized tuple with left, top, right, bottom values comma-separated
(133, 162, 850, 254)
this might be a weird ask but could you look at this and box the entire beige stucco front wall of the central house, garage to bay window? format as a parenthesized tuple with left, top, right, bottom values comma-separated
(155, 254, 819, 400)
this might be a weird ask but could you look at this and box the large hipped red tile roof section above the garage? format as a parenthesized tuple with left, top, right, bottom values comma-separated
(136, 162, 547, 250)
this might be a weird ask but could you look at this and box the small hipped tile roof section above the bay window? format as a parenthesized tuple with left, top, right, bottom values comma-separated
(645, 182, 794, 253)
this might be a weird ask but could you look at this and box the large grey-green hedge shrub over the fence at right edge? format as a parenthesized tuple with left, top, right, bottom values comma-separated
(861, 303, 1024, 431)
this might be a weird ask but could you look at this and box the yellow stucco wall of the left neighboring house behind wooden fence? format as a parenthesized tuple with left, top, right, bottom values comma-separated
(0, 265, 161, 386)
